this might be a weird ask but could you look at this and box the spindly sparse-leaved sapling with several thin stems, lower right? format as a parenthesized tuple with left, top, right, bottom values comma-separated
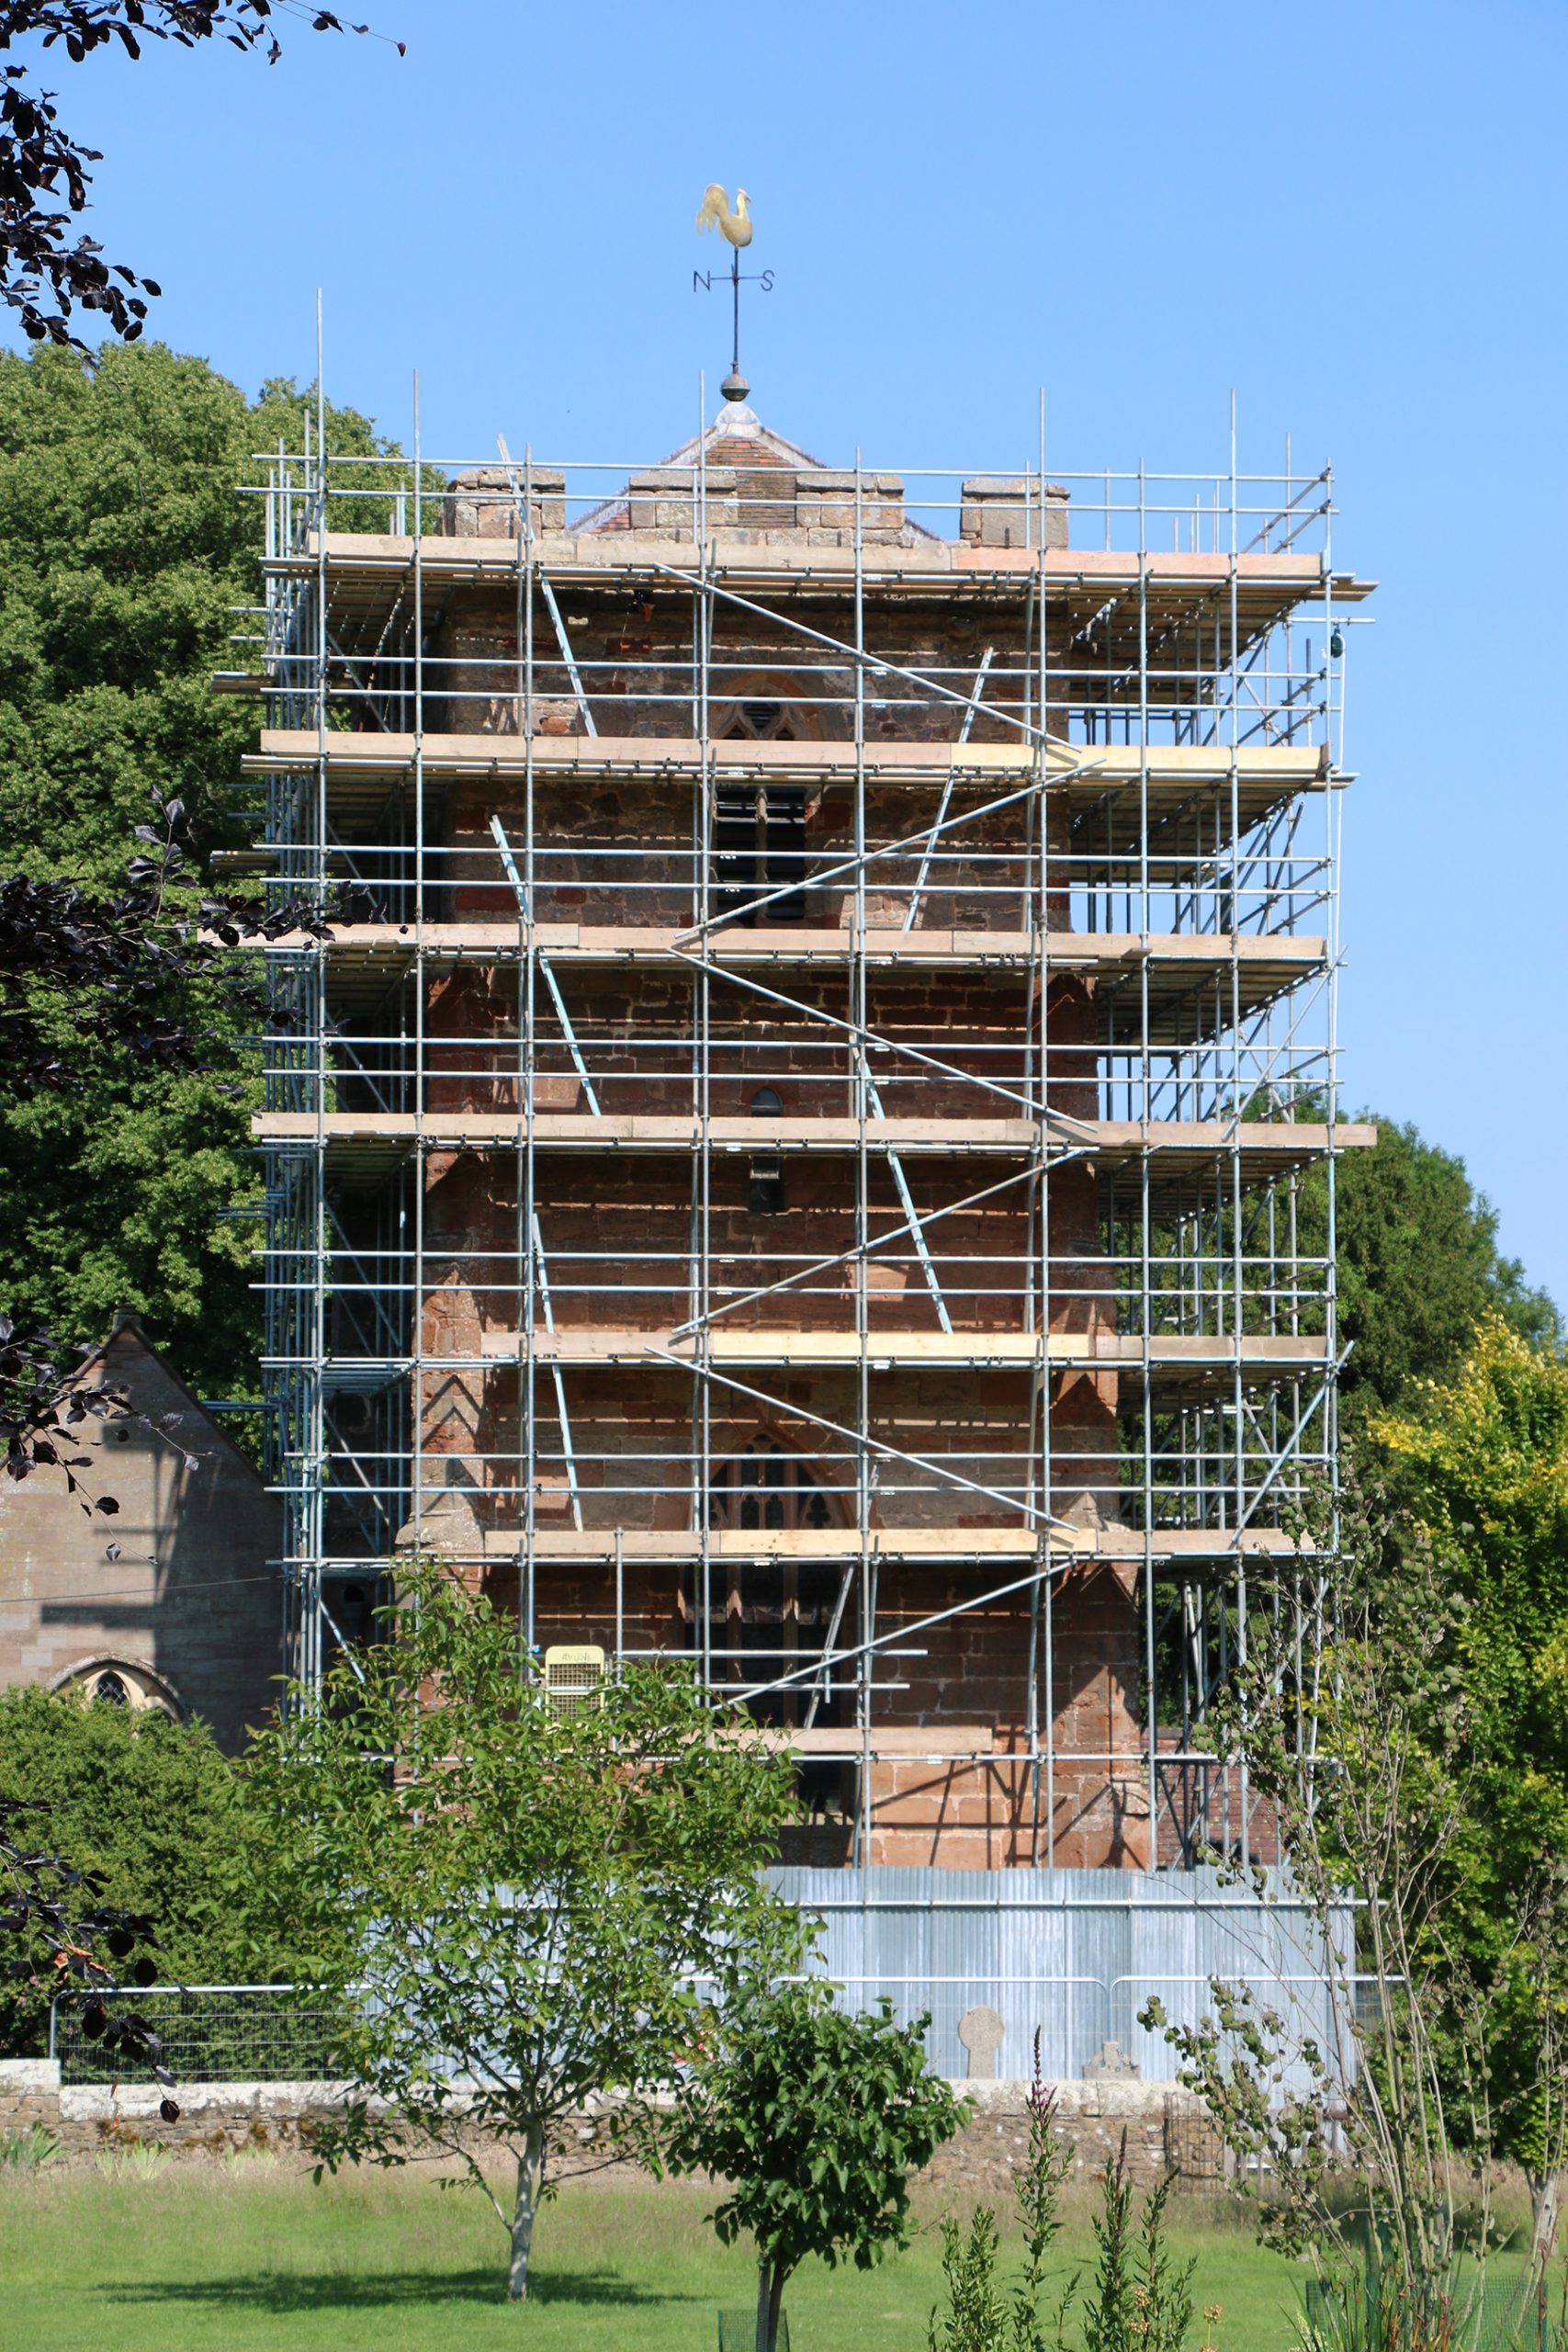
(1140, 1491, 1568, 2347)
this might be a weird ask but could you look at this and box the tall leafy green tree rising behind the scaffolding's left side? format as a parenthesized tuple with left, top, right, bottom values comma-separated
(0, 345, 411, 1397)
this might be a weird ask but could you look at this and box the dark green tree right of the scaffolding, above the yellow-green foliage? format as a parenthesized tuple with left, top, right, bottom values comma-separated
(1300, 1113, 1559, 1428)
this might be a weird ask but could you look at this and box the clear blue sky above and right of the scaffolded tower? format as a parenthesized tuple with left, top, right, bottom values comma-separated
(15, 0, 1568, 1303)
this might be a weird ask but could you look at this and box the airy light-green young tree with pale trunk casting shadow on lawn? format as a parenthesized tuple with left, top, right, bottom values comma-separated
(249, 1564, 802, 2298)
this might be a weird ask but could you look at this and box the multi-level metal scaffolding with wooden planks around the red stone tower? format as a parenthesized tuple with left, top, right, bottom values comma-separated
(236, 404, 1371, 1868)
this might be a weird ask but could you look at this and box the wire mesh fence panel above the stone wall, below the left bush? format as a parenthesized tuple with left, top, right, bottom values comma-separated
(50, 1985, 344, 2084)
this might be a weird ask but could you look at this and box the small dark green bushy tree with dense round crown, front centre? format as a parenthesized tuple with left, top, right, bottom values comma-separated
(668, 1981, 968, 2352)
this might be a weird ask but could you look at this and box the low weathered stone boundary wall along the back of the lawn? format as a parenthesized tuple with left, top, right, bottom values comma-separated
(0, 2058, 1224, 2204)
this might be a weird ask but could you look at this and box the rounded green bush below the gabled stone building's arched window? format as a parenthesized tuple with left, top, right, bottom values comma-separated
(0, 1687, 320, 2055)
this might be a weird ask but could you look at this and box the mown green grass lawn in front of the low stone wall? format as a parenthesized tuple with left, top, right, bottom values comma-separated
(0, 2159, 1300, 2352)
